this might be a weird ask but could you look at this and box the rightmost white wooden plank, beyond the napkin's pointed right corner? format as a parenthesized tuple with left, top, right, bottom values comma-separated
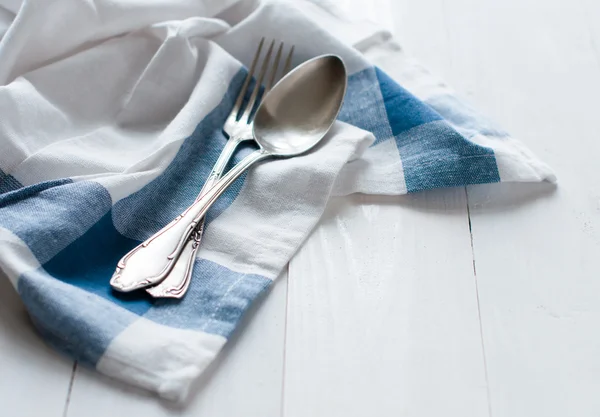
(440, 0, 600, 417)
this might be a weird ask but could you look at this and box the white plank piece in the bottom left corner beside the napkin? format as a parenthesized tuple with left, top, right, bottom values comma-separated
(0, 272, 73, 417)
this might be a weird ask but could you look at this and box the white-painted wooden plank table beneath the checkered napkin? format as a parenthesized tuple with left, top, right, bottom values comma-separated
(0, 0, 600, 417)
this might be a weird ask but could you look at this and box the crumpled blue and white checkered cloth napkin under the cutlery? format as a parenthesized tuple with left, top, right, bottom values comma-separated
(0, 0, 554, 399)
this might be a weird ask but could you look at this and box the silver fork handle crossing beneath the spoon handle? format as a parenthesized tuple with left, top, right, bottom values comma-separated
(146, 135, 247, 298)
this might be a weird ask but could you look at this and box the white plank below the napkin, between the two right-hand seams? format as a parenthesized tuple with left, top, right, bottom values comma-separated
(284, 192, 488, 417)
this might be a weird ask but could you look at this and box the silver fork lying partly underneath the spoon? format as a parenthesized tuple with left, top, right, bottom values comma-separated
(146, 38, 294, 298)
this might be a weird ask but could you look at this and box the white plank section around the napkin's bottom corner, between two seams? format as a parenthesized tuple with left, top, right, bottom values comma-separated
(66, 274, 287, 417)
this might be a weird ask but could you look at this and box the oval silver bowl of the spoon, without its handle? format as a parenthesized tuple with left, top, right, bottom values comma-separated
(253, 55, 347, 157)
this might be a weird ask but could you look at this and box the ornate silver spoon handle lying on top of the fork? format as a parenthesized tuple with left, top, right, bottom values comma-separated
(110, 149, 271, 292)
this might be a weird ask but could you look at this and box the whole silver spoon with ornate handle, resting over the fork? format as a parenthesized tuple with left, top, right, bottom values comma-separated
(110, 55, 347, 292)
